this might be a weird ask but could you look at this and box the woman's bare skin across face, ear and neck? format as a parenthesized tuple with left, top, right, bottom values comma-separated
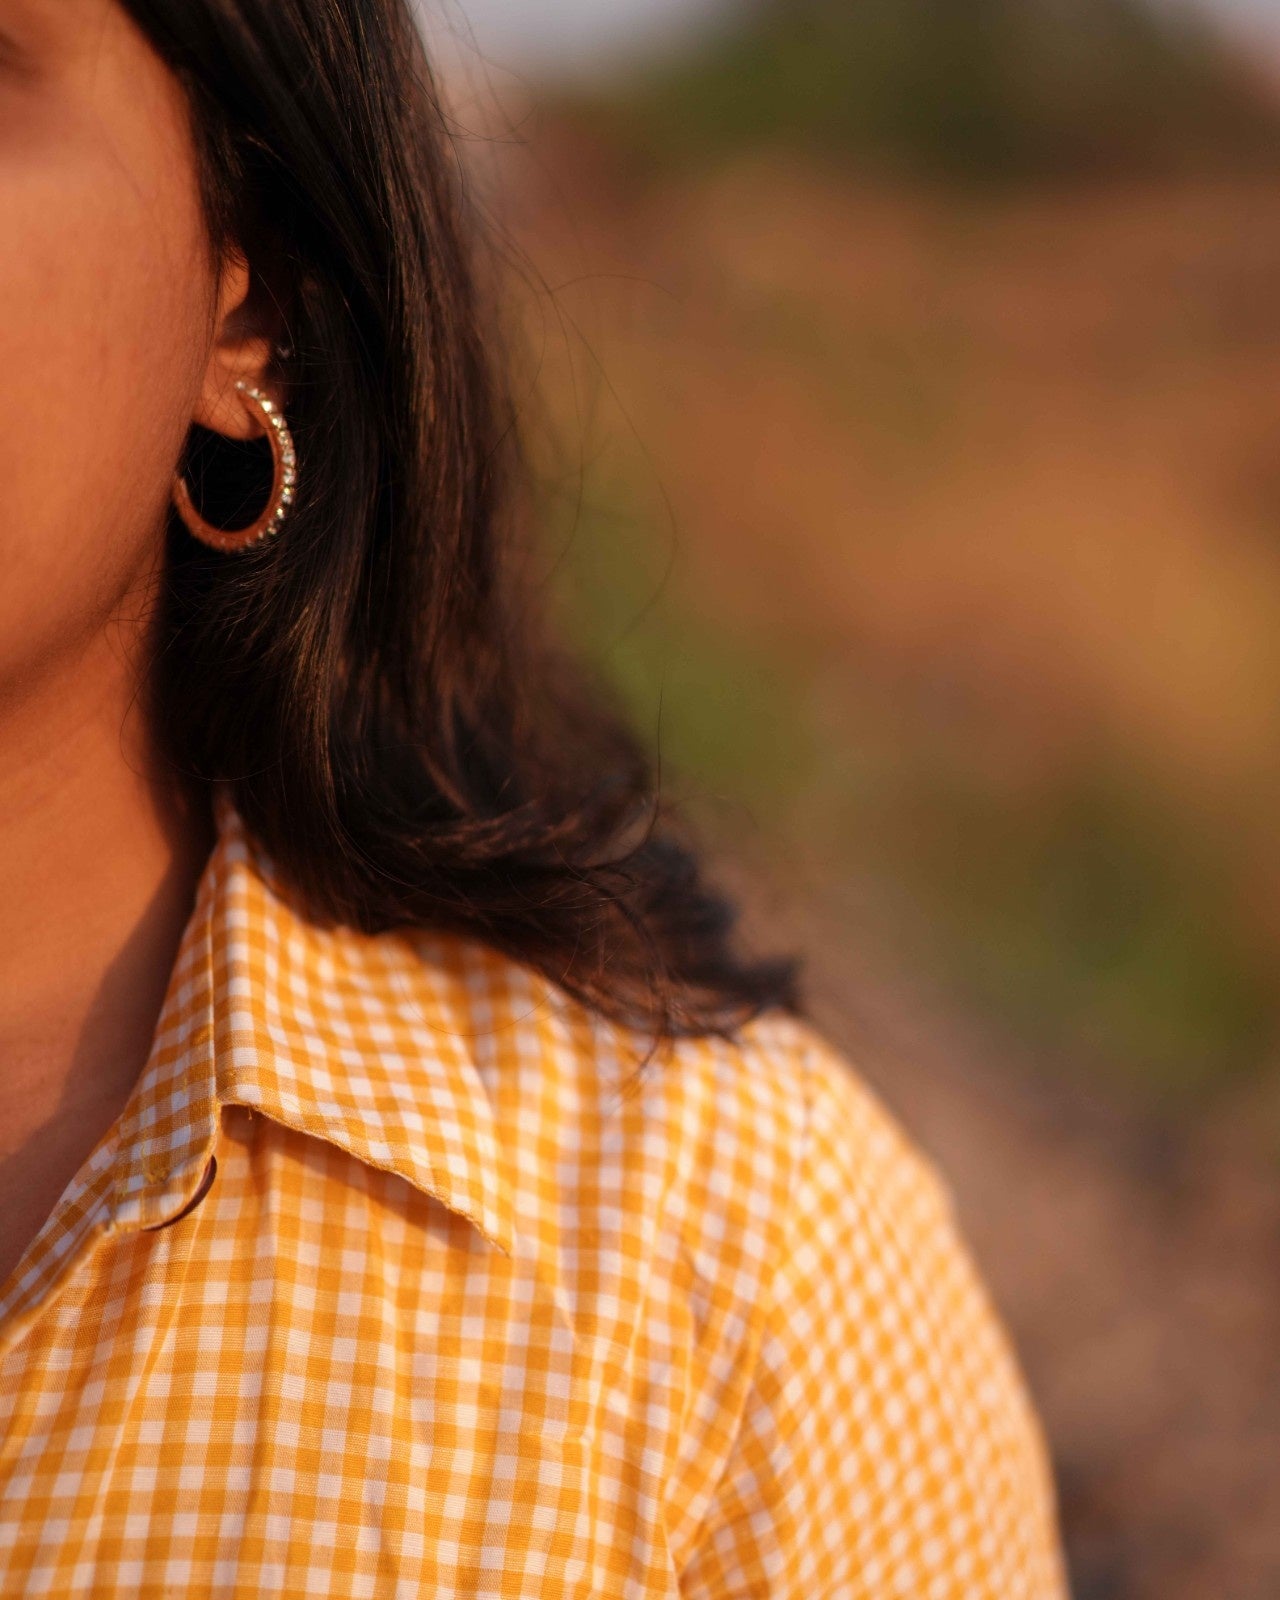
(0, 0, 286, 1282)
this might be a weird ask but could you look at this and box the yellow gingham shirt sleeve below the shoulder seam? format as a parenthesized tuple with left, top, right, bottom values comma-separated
(680, 1035, 1067, 1600)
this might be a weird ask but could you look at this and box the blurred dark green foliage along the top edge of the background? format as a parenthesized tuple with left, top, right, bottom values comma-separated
(566, 0, 1280, 181)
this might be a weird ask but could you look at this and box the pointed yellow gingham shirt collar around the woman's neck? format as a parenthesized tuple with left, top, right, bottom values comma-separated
(112, 786, 515, 1254)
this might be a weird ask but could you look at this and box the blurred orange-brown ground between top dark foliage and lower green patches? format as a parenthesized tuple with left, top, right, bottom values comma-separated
(504, 134, 1280, 954)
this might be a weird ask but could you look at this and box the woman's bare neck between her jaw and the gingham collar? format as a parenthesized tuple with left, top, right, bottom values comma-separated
(0, 637, 213, 1162)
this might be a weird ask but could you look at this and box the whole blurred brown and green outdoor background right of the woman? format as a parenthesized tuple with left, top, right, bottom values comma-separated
(422, 0, 1280, 1600)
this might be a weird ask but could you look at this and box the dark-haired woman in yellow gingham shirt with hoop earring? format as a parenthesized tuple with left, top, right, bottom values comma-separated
(0, 0, 1064, 1600)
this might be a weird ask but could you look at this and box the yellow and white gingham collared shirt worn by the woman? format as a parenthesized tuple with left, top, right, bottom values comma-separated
(0, 795, 1066, 1600)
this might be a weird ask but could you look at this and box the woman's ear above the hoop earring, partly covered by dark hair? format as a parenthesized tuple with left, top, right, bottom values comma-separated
(192, 251, 285, 438)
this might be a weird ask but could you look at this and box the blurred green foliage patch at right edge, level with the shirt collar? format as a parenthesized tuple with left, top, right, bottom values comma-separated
(882, 752, 1280, 1101)
